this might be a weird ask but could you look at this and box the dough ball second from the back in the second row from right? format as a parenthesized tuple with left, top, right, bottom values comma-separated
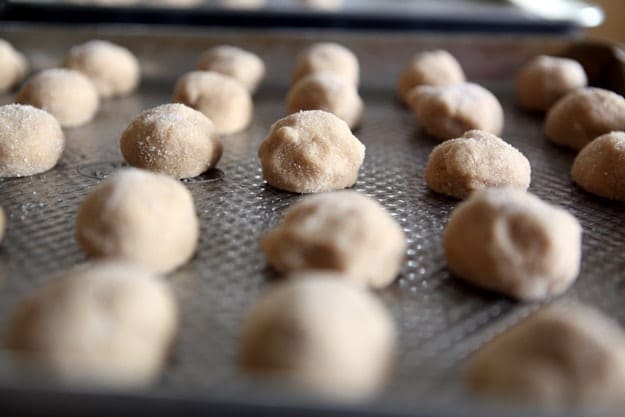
(408, 83, 503, 140)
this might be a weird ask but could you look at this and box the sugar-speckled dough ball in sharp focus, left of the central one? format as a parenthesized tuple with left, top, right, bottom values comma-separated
(120, 104, 223, 178)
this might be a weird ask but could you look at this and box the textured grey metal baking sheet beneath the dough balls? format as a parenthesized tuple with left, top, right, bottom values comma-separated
(0, 25, 625, 416)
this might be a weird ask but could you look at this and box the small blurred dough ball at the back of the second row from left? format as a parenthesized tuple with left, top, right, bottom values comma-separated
(196, 45, 265, 93)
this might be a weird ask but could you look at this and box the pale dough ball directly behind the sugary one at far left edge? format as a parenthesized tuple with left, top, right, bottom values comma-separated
(15, 68, 100, 127)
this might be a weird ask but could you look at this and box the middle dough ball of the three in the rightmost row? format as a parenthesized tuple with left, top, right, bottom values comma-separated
(545, 87, 625, 150)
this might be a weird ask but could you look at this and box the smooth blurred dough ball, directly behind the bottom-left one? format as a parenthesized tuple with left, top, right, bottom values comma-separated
(76, 168, 199, 272)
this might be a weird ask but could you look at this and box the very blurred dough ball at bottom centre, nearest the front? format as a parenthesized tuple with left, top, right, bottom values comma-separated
(240, 272, 396, 400)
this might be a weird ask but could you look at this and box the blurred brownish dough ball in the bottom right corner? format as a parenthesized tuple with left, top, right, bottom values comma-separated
(467, 303, 625, 411)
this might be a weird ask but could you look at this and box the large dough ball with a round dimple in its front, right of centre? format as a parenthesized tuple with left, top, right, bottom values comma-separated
(443, 188, 582, 301)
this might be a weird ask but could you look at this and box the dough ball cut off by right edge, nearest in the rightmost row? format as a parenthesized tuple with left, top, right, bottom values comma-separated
(571, 132, 625, 201)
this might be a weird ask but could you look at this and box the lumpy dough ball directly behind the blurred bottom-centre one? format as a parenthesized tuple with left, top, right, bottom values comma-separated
(261, 191, 406, 288)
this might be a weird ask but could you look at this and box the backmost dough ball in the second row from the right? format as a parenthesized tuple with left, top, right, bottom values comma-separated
(397, 49, 465, 102)
